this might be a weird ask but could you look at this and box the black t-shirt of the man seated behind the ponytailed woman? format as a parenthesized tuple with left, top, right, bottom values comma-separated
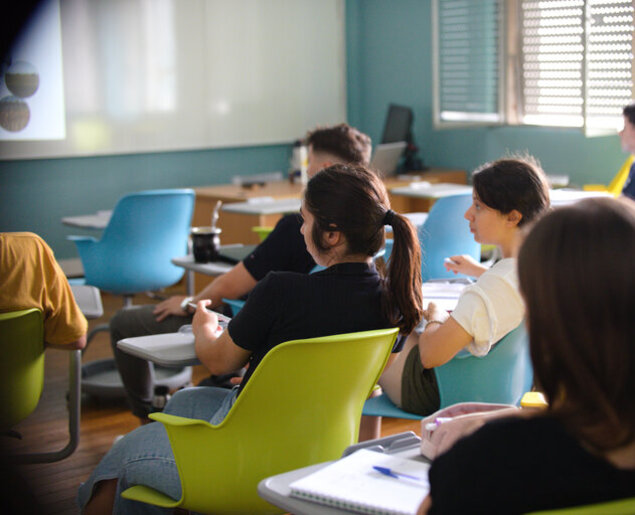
(243, 213, 315, 281)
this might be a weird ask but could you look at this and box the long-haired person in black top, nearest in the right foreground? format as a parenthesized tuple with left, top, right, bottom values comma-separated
(419, 199, 635, 514)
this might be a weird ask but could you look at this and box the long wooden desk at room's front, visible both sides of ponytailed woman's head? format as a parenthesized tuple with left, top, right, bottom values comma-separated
(192, 168, 467, 245)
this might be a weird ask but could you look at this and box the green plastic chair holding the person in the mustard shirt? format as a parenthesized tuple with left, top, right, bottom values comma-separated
(0, 308, 81, 463)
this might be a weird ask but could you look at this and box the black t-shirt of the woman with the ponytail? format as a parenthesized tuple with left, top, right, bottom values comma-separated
(227, 263, 398, 389)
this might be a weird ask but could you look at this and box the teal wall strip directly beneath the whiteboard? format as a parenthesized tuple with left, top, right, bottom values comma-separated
(0, 145, 291, 259)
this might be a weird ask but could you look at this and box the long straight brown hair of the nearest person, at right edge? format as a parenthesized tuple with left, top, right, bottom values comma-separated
(518, 199, 635, 451)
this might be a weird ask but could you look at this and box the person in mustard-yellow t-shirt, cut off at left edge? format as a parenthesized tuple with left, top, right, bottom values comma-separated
(0, 232, 88, 350)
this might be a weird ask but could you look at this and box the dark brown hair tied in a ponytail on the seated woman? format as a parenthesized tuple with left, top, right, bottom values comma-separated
(304, 164, 423, 333)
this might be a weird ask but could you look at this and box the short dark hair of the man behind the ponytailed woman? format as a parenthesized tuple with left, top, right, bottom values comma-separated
(304, 123, 372, 165)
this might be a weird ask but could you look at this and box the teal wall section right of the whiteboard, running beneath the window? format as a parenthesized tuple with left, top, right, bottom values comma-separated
(347, 0, 627, 184)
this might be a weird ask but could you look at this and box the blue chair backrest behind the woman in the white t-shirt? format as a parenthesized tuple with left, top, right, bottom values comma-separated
(434, 323, 533, 408)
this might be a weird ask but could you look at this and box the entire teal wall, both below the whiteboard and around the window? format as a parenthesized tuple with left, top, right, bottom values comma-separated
(0, 0, 626, 259)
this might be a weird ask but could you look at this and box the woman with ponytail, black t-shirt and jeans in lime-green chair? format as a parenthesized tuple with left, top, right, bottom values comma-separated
(79, 165, 422, 513)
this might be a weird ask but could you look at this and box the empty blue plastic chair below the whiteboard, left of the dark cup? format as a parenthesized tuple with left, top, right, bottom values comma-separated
(68, 189, 194, 397)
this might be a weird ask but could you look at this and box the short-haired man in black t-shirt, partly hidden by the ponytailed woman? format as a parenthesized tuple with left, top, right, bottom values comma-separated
(110, 124, 371, 422)
